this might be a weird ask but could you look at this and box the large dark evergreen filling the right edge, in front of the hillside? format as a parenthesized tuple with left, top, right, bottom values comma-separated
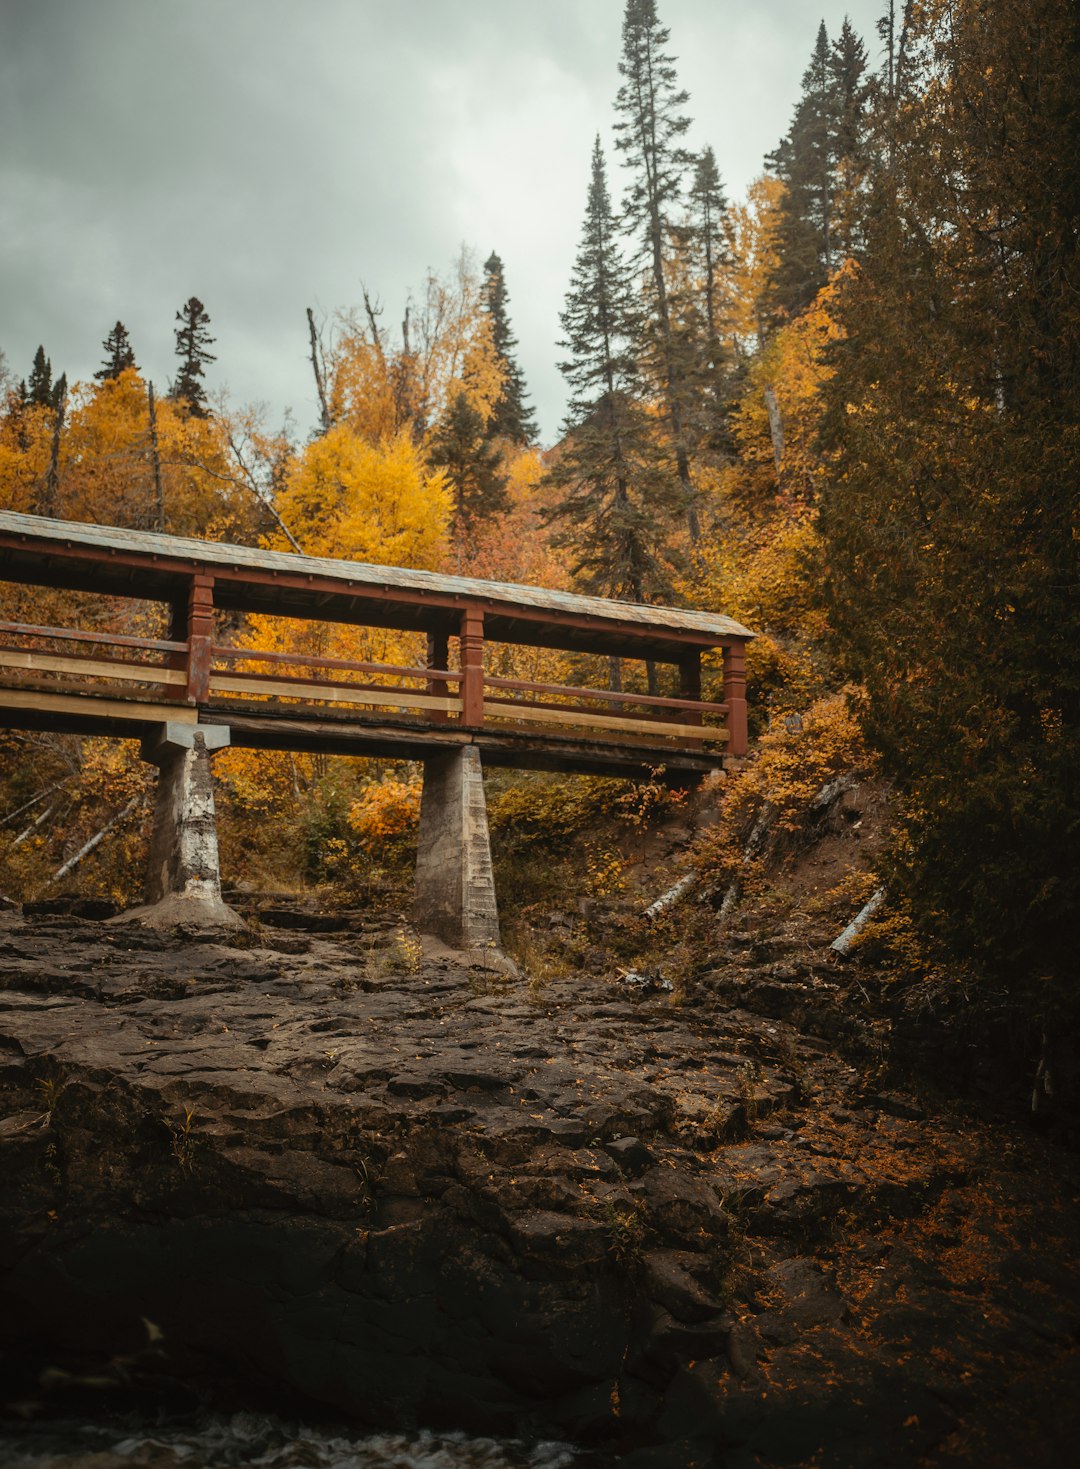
(821, 0, 1080, 998)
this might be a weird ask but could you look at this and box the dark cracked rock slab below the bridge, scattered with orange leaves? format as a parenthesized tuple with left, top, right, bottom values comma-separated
(0, 912, 1080, 1469)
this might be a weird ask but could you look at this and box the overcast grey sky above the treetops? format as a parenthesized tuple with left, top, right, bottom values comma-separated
(0, 0, 883, 442)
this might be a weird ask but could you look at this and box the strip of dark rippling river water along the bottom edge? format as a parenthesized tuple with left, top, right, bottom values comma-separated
(0, 1413, 589, 1469)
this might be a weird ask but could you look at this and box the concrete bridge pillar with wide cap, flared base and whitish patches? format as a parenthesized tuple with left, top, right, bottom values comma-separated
(131, 723, 242, 927)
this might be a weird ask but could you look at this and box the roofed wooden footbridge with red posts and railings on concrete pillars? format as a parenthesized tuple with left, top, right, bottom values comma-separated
(0, 511, 754, 942)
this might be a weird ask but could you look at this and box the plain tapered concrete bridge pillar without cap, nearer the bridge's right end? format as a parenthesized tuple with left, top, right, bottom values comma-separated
(413, 745, 500, 950)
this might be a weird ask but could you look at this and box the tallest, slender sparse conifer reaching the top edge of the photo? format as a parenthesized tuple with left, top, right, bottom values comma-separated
(616, 0, 701, 541)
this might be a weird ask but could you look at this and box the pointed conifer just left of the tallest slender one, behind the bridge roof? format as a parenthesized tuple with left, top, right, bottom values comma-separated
(548, 138, 679, 602)
